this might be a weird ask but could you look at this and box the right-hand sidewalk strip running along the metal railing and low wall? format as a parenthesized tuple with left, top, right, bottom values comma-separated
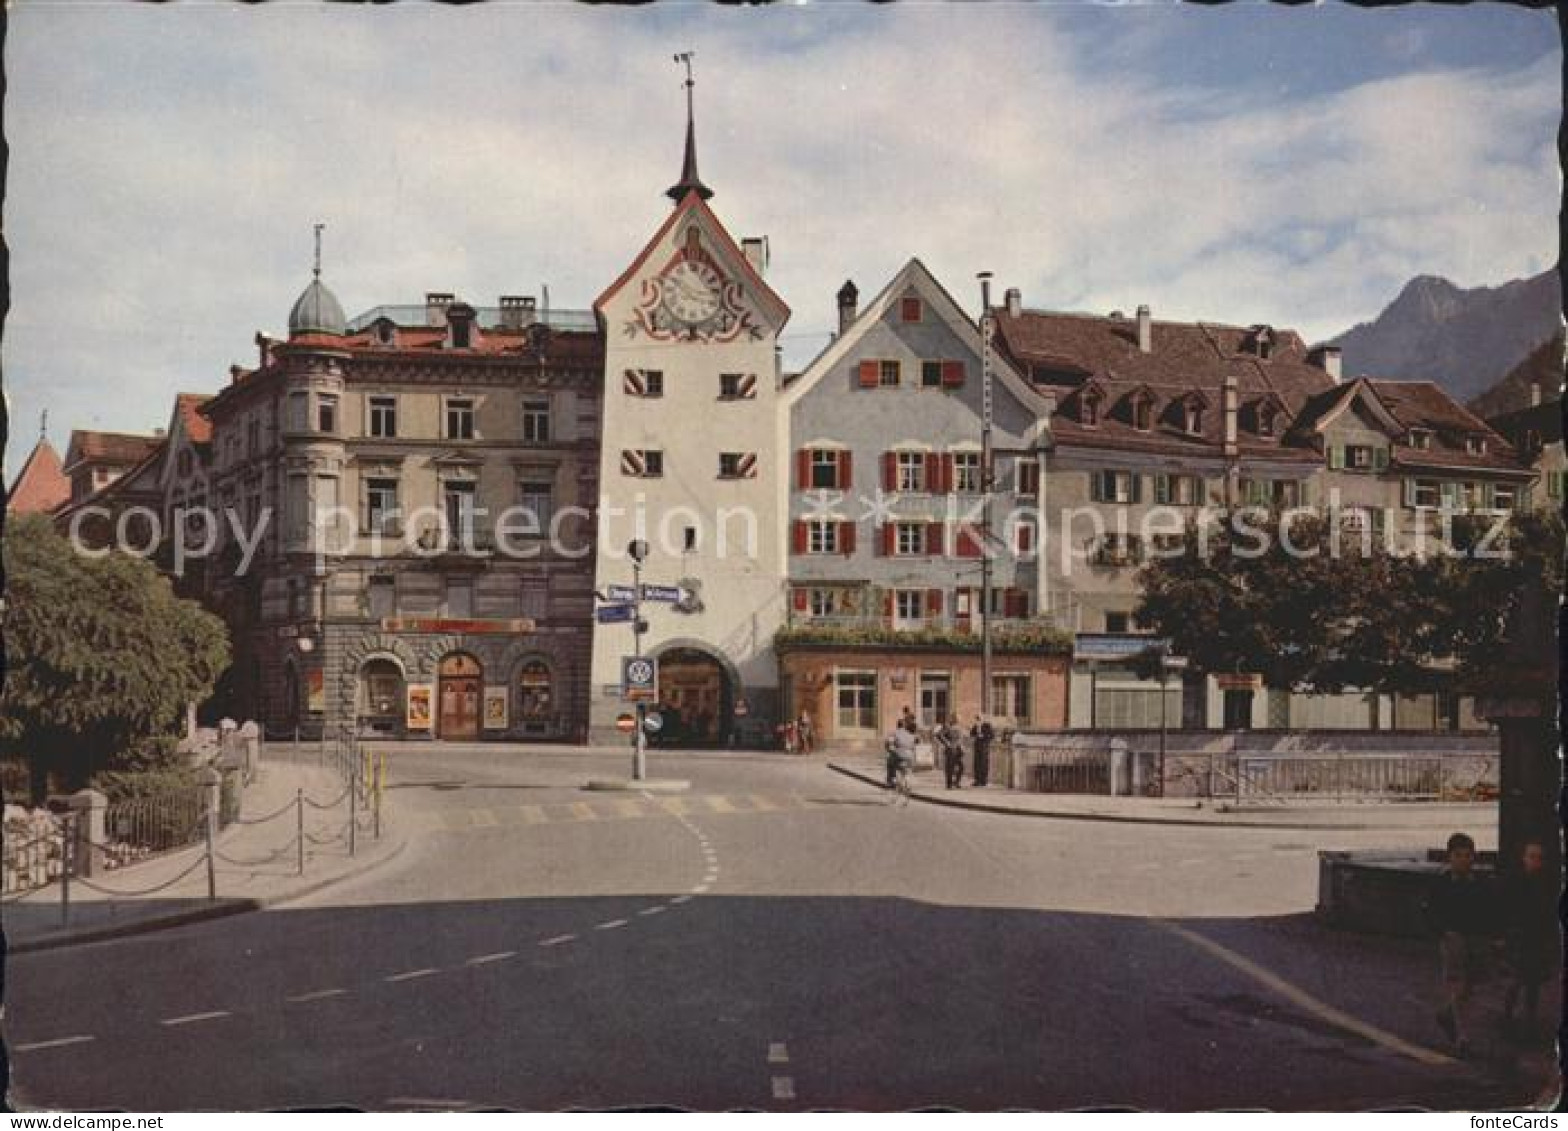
(828, 758, 1497, 831)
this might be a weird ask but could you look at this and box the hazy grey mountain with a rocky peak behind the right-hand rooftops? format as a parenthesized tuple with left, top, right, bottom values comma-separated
(1333, 268, 1562, 402)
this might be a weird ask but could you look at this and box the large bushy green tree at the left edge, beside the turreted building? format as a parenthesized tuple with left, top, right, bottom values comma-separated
(0, 516, 229, 800)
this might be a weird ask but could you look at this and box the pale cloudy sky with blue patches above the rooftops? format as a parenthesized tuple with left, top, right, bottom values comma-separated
(0, 0, 1562, 480)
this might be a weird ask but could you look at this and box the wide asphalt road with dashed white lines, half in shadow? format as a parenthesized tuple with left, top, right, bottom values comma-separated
(5, 747, 1543, 1111)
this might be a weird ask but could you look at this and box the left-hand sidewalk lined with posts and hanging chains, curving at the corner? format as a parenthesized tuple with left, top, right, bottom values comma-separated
(0, 761, 408, 954)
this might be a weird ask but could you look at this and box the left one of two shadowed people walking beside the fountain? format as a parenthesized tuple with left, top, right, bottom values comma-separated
(1425, 833, 1494, 1056)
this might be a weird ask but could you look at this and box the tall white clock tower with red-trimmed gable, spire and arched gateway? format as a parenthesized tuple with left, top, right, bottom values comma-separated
(591, 63, 789, 745)
